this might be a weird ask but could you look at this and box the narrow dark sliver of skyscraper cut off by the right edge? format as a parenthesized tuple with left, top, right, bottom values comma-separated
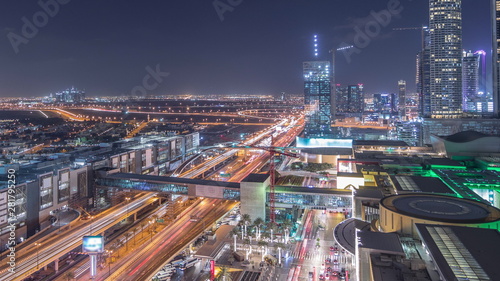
(491, 0, 500, 116)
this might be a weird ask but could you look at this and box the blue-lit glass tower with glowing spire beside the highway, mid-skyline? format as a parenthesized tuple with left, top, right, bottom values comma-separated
(303, 35, 333, 138)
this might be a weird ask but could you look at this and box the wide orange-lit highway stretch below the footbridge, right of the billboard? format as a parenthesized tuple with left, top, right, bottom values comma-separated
(104, 199, 237, 281)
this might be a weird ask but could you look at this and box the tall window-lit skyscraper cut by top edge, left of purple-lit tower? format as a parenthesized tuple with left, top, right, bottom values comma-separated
(429, 0, 462, 118)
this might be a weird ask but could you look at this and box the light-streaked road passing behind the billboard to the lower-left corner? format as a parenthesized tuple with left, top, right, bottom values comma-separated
(0, 193, 157, 281)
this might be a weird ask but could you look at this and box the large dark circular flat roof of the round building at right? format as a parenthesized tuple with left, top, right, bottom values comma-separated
(380, 194, 500, 224)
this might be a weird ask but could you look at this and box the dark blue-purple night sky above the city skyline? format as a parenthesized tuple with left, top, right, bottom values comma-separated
(0, 0, 491, 97)
